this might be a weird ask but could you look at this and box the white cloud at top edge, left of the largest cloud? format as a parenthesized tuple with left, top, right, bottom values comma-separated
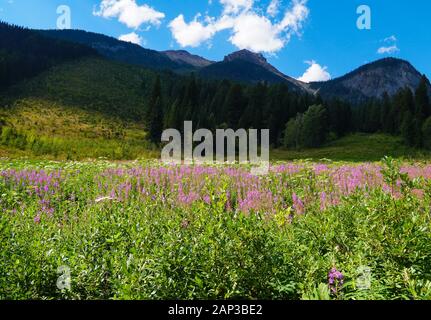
(93, 0, 165, 29)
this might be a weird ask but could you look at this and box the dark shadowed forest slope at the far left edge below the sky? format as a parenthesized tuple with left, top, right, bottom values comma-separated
(0, 21, 97, 89)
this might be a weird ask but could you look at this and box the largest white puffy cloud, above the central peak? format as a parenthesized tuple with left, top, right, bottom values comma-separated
(169, 0, 309, 53)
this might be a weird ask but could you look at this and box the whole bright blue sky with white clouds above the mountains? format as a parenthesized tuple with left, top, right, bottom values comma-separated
(0, 0, 431, 80)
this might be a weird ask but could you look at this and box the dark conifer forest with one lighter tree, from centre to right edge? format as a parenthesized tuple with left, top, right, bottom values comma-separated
(146, 74, 431, 149)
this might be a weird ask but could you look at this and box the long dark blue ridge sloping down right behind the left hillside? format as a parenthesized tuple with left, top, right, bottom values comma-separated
(39, 30, 194, 70)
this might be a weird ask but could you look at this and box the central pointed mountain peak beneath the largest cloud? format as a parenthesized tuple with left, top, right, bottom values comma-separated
(199, 50, 310, 92)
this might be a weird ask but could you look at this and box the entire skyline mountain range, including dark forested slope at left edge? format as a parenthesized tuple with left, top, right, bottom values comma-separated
(0, 23, 431, 104)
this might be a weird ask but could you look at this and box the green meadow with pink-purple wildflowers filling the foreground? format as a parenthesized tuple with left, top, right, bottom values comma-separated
(0, 158, 431, 300)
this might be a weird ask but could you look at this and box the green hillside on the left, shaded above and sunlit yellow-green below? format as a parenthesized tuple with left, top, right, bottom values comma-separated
(0, 58, 162, 159)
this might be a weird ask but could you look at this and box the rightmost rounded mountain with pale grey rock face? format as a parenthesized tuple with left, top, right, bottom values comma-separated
(310, 58, 431, 104)
